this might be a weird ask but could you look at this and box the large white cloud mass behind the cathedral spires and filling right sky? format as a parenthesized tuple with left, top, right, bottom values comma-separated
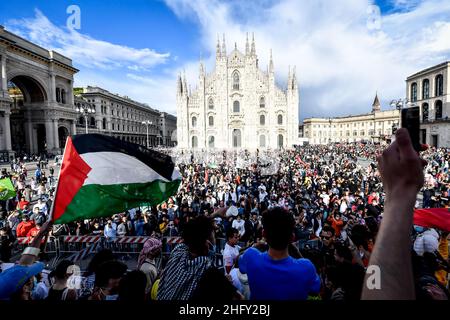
(165, 0, 450, 118)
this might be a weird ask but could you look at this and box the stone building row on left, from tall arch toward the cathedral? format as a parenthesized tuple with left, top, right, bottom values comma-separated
(0, 26, 176, 162)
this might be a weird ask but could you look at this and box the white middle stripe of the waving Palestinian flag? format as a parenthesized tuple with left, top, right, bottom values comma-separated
(80, 152, 173, 185)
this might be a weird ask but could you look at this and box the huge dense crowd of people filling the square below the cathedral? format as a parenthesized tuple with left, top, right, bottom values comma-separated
(0, 134, 450, 301)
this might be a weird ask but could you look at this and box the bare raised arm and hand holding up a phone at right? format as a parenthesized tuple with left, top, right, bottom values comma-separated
(362, 129, 425, 300)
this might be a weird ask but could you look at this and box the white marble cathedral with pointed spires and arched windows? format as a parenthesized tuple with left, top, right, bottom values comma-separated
(177, 36, 299, 150)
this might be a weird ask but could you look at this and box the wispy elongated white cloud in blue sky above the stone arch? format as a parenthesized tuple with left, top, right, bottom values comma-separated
(6, 9, 170, 70)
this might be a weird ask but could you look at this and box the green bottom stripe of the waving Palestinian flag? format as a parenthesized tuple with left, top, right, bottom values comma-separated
(55, 180, 181, 224)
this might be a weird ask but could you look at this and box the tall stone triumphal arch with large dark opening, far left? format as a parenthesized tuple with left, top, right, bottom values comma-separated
(0, 26, 78, 157)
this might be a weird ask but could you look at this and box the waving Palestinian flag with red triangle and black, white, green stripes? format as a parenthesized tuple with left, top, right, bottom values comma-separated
(53, 134, 181, 224)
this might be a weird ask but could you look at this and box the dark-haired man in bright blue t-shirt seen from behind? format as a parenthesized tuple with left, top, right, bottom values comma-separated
(239, 207, 321, 300)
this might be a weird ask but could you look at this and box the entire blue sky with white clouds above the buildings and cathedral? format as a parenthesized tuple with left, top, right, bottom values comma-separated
(0, 0, 450, 119)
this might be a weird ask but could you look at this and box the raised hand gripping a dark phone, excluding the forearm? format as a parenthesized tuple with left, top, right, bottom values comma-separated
(377, 128, 426, 195)
